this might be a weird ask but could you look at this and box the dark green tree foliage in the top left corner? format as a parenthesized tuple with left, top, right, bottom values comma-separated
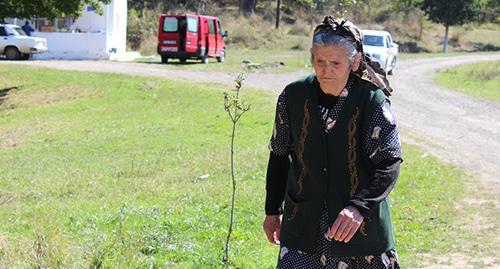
(0, 0, 111, 20)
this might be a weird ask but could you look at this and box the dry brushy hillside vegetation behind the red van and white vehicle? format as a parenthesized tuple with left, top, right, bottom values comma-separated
(127, 0, 500, 59)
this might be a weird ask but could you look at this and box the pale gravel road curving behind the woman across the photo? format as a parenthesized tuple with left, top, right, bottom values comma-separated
(1, 54, 500, 188)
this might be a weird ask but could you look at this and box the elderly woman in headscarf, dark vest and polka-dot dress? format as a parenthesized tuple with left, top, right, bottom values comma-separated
(263, 17, 402, 269)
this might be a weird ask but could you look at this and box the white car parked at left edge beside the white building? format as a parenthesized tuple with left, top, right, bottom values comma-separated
(0, 24, 47, 60)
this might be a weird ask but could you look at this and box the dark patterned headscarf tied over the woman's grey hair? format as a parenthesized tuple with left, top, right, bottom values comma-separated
(314, 16, 392, 96)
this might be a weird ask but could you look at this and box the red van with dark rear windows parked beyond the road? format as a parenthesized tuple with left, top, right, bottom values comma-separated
(158, 14, 227, 63)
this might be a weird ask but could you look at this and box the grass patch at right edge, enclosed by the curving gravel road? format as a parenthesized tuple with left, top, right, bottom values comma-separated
(435, 61, 500, 101)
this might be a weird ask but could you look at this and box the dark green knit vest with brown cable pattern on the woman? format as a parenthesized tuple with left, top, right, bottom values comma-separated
(280, 74, 394, 256)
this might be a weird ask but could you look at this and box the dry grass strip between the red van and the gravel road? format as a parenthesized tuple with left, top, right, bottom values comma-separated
(135, 48, 310, 73)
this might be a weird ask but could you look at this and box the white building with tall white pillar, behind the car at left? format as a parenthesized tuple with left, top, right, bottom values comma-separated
(6, 0, 130, 60)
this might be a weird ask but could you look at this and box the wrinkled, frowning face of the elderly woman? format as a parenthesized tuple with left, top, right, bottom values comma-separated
(311, 45, 359, 91)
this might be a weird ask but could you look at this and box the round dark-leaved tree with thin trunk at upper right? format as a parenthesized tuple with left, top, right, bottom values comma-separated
(420, 0, 479, 53)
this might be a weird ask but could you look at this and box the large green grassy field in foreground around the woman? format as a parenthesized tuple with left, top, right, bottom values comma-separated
(0, 66, 484, 268)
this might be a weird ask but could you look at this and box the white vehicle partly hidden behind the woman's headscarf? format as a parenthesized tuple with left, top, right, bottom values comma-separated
(362, 30, 399, 75)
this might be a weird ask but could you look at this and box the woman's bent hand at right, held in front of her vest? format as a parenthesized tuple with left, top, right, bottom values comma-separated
(325, 206, 364, 243)
